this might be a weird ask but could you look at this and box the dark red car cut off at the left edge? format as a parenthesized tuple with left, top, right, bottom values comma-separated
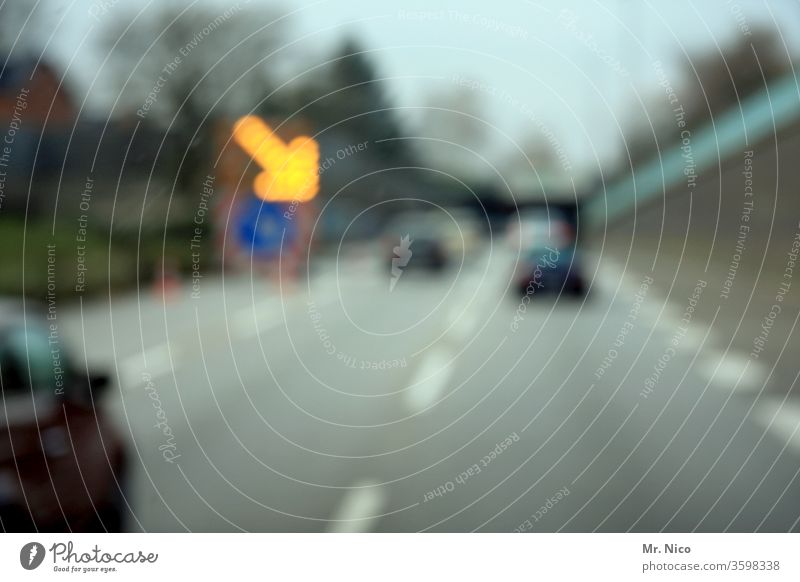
(0, 304, 125, 532)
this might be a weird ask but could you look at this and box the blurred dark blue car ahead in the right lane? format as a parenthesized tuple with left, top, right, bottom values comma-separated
(509, 208, 586, 296)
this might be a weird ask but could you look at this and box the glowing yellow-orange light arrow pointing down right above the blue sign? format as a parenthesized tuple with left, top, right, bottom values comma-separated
(233, 115, 319, 202)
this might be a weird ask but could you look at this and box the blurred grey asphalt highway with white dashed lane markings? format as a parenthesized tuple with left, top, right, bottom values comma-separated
(57, 246, 800, 531)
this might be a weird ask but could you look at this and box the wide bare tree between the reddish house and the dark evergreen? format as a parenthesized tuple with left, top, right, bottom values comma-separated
(99, 4, 285, 190)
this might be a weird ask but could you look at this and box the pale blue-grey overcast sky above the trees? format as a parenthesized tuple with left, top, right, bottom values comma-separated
(18, 0, 800, 180)
